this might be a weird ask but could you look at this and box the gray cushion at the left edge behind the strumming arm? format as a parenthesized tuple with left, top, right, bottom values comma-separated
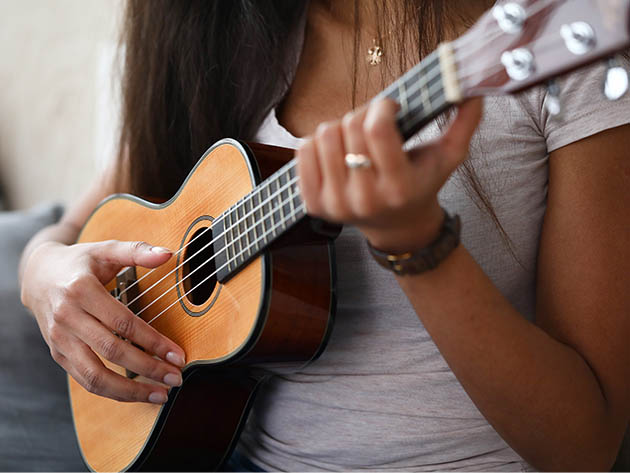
(0, 205, 85, 471)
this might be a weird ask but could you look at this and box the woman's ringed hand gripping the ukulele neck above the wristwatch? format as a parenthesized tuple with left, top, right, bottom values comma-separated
(297, 99, 482, 253)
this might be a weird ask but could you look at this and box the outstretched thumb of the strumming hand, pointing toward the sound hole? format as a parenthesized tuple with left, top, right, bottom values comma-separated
(90, 240, 173, 280)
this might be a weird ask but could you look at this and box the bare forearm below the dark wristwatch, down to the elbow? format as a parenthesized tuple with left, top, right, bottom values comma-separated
(399, 246, 625, 471)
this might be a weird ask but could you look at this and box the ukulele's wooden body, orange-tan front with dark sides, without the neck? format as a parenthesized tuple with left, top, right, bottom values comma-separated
(68, 140, 335, 471)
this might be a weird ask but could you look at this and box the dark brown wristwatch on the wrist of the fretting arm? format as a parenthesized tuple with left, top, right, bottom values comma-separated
(366, 210, 462, 276)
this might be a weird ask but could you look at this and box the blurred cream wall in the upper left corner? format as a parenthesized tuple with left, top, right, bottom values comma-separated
(0, 0, 124, 210)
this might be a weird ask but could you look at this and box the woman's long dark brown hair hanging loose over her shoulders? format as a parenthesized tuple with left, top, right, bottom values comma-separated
(118, 0, 514, 254)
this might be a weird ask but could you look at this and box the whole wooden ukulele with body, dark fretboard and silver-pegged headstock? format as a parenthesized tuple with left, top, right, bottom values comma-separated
(68, 0, 630, 471)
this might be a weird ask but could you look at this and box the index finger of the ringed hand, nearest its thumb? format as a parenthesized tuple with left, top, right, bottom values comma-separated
(363, 100, 408, 179)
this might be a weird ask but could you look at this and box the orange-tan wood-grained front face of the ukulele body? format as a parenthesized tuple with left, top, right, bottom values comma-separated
(69, 141, 263, 471)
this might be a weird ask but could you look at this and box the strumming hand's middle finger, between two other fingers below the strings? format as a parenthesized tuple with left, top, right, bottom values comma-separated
(66, 306, 182, 386)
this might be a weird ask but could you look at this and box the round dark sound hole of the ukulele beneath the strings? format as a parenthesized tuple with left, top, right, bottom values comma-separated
(182, 227, 217, 305)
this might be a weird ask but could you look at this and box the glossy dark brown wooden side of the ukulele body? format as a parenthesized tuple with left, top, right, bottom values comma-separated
(129, 145, 340, 471)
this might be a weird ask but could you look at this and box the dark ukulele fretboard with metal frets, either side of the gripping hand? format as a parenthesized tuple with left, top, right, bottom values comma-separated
(212, 44, 462, 282)
